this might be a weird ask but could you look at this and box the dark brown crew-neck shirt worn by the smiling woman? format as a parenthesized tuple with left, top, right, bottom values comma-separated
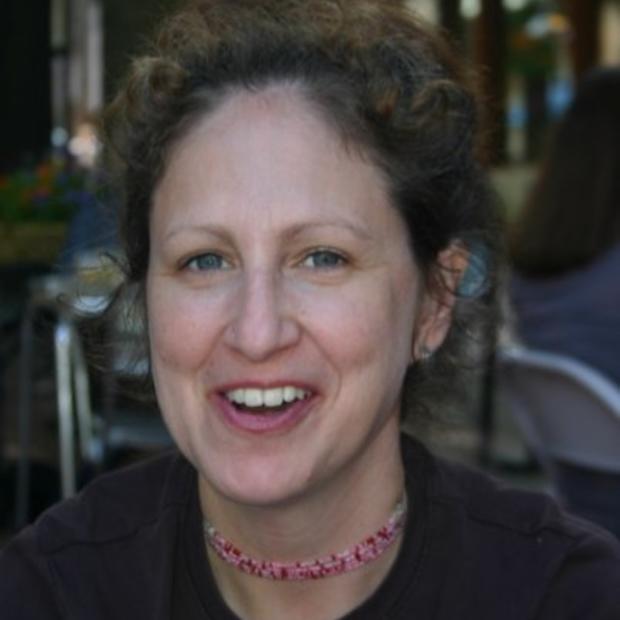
(0, 439, 620, 620)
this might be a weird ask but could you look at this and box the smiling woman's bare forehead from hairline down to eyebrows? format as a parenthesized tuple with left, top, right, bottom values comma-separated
(152, 86, 400, 242)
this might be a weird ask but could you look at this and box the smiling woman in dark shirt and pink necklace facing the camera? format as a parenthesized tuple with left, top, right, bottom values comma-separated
(0, 0, 620, 620)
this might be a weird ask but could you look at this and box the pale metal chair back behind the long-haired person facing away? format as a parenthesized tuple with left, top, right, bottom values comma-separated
(496, 346, 620, 536)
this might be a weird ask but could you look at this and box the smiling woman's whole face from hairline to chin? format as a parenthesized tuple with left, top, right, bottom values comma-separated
(147, 87, 444, 505)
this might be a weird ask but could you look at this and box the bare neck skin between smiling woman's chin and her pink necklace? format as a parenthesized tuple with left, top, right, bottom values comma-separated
(199, 426, 404, 562)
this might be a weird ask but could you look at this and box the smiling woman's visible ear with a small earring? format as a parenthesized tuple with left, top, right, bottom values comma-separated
(412, 242, 469, 361)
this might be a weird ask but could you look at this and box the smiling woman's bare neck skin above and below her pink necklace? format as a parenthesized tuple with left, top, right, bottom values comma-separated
(200, 428, 404, 620)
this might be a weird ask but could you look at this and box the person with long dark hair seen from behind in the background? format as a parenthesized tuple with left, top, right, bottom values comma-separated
(510, 68, 620, 385)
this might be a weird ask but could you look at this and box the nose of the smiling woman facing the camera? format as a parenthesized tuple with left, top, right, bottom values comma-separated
(225, 270, 301, 362)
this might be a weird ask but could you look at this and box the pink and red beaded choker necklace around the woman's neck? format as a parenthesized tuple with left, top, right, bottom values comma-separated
(203, 496, 407, 581)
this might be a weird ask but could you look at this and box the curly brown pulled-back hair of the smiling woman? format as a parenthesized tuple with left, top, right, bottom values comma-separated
(101, 0, 494, 422)
